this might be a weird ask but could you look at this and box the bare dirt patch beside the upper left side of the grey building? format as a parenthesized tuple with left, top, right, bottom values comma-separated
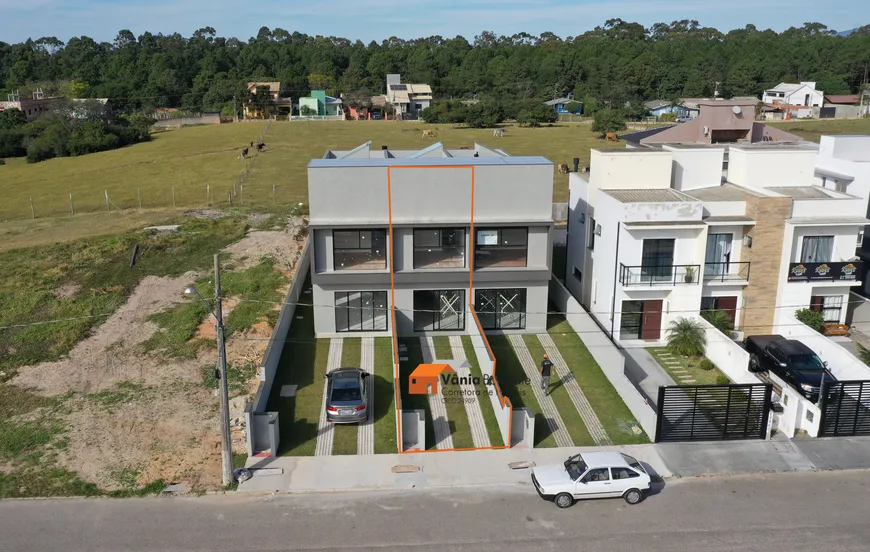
(224, 217, 305, 276)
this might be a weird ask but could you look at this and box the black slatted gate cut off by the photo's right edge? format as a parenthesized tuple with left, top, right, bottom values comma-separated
(819, 381, 870, 437)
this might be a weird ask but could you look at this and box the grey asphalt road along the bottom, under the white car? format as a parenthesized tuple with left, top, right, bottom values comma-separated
(0, 471, 870, 552)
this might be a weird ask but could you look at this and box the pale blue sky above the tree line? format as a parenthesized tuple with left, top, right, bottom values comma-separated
(0, 0, 870, 43)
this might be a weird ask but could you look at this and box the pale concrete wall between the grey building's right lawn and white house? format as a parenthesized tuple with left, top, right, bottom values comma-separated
(550, 277, 656, 440)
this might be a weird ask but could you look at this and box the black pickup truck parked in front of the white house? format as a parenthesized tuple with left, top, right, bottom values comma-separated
(744, 335, 837, 402)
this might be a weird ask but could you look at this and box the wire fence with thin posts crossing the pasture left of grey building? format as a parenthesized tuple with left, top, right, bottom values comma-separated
(0, 120, 306, 222)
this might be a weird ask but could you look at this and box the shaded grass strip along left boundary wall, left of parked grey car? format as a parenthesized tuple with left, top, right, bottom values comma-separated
(266, 276, 329, 456)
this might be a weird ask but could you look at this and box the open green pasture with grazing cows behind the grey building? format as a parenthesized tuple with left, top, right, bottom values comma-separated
(0, 121, 623, 221)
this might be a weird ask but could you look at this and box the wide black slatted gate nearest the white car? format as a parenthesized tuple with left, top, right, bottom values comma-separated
(656, 383, 773, 443)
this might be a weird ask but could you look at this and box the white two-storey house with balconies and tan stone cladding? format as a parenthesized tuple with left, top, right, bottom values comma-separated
(565, 137, 870, 341)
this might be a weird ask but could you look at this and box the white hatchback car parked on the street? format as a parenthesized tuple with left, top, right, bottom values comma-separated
(532, 452, 650, 508)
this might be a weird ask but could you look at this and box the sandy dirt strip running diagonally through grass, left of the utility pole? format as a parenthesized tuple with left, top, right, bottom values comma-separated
(12, 272, 204, 395)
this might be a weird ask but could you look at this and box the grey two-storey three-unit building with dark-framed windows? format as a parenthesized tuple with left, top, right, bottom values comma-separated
(308, 142, 553, 337)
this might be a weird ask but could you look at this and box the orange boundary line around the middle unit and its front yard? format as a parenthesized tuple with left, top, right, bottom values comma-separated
(387, 165, 513, 454)
